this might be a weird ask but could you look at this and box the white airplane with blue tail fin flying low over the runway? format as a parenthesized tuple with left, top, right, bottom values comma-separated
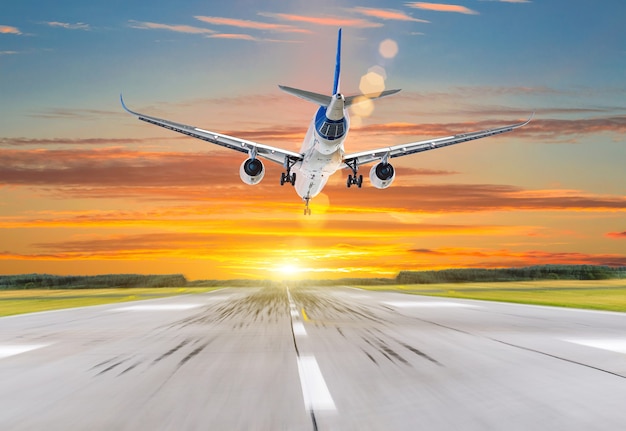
(120, 29, 534, 215)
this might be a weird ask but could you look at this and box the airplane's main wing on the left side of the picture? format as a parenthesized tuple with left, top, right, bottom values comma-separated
(120, 94, 303, 166)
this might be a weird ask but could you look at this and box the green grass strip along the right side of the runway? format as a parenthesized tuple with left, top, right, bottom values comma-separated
(358, 279, 626, 311)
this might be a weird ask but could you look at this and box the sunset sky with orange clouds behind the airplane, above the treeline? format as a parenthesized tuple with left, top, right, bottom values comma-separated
(0, 0, 626, 279)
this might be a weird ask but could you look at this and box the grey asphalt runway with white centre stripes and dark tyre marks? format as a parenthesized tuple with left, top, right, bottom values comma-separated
(0, 288, 626, 430)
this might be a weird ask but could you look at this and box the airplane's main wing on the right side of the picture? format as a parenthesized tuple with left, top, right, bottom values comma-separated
(343, 112, 535, 168)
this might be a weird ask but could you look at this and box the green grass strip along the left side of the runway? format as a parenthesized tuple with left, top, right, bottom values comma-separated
(0, 287, 217, 317)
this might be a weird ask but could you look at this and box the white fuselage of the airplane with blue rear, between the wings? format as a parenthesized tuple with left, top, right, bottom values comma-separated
(292, 94, 350, 201)
